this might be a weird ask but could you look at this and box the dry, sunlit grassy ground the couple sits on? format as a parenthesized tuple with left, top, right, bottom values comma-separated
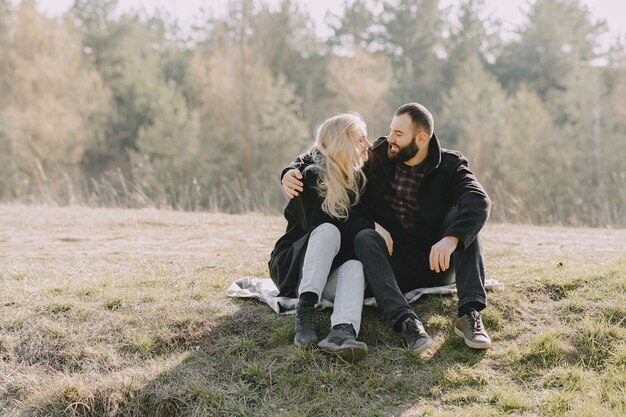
(0, 206, 626, 417)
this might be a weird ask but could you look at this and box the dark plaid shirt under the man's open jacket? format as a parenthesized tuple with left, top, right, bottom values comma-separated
(385, 161, 428, 229)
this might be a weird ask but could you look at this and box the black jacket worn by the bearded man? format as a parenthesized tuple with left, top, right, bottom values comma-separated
(283, 133, 491, 252)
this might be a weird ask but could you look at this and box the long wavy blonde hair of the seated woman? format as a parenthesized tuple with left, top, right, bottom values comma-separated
(311, 113, 367, 220)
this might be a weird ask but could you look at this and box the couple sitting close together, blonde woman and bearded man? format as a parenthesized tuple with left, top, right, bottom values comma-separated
(269, 103, 491, 361)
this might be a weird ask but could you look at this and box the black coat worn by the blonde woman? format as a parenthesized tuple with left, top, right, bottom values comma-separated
(268, 162, 374, 298)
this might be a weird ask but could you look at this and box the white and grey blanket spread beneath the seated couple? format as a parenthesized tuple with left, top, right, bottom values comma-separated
(226, 277, 504, 314)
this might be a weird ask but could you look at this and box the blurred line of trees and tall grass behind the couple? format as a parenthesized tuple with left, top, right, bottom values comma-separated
(0, 0, 626, 226)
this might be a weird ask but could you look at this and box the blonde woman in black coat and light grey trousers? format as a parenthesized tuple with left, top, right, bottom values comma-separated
(269, 113, 374, 361)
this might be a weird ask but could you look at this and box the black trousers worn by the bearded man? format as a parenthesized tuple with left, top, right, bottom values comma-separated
(354, 223, 487, 330)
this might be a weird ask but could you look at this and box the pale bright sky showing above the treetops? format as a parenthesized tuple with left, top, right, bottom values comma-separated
(37, 0, 626, 38)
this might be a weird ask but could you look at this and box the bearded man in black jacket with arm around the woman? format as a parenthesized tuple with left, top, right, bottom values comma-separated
(282, 103, 491, 353)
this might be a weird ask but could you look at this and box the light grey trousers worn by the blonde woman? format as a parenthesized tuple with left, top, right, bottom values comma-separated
(298, 223, 365, 335)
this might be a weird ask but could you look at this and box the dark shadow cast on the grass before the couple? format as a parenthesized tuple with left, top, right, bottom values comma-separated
(36, 297, 483, 417)
